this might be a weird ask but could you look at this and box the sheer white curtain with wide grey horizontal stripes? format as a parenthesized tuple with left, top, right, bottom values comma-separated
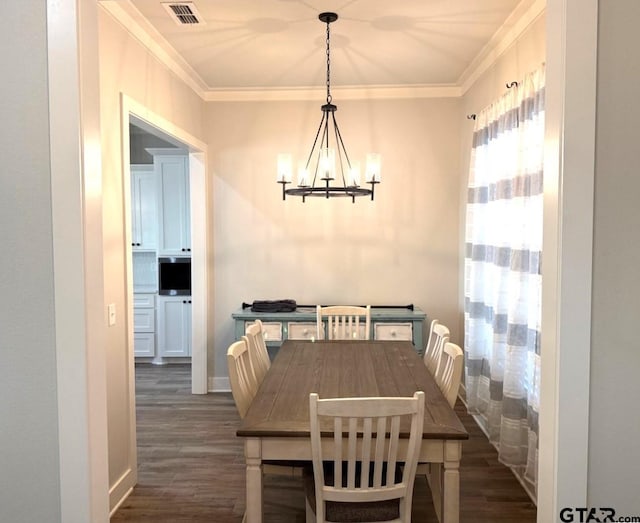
(465, 67, 544, 495)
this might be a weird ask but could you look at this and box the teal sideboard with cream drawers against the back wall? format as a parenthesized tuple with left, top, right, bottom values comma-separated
(231, 307, 427, 358)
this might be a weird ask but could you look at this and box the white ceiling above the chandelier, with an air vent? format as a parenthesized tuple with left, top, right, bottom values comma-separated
(106, 0, 539, 92)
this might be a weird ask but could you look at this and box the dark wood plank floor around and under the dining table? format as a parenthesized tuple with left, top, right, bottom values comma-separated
(111, 365, 536, 523)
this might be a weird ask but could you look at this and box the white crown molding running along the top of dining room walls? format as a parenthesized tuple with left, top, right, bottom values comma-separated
(99, 0, 546, 102)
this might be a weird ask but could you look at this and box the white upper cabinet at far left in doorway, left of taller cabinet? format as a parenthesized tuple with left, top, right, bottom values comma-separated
(130, 165, 158, 251)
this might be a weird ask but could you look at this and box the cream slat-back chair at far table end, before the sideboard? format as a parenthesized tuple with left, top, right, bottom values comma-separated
(316, 305, 371, 340)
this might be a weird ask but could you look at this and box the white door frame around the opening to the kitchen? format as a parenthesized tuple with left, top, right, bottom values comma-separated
(120, 93, 209, 398)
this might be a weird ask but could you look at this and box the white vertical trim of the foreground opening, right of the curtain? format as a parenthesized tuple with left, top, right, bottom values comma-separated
(538, 0, 598, 523)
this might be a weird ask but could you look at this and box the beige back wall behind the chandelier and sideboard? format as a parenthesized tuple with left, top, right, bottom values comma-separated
(206, 96, 466, 376)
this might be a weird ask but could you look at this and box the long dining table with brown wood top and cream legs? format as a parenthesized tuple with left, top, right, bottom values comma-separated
(237, 339, 469, 523)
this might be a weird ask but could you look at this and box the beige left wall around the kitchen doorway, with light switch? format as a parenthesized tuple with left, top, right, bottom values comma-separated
(99, 11, 203, 508)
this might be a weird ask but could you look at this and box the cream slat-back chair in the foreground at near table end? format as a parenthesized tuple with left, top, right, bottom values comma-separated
(305, 391, 424, 523)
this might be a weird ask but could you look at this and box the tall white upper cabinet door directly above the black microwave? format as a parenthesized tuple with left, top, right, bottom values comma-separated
(154, 156, 191, 256)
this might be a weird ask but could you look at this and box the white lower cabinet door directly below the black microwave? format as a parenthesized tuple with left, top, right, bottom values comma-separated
(157, 296, 191, 358)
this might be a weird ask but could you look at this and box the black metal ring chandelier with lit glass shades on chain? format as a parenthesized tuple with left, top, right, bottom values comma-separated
(277, 13, 380, 202)
